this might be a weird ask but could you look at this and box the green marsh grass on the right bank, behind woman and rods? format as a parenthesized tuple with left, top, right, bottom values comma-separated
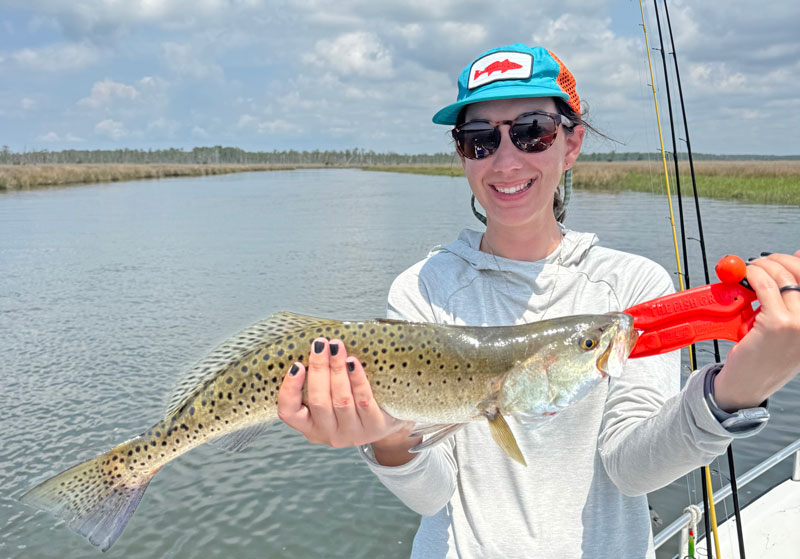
(364, 160, 800, 206)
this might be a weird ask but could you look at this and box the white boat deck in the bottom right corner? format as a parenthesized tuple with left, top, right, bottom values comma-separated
(695, 479, 800, 559)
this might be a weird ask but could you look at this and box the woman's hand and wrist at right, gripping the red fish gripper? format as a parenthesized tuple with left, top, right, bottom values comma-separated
(714, 251, 800, 411)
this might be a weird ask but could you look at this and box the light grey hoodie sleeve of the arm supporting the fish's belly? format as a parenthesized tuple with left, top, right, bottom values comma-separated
(359, 268, 457, 516)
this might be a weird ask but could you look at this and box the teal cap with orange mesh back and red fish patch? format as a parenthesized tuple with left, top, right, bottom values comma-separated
(433, 43, 581, 125)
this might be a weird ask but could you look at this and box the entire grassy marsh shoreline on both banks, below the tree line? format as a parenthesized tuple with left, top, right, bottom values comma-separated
(0, 161, 800, 206)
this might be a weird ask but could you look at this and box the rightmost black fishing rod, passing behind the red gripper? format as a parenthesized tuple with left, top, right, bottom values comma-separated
(653, 0, 745, 559)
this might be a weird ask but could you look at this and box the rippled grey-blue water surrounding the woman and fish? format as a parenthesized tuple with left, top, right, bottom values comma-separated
(0, 170, 800, 559)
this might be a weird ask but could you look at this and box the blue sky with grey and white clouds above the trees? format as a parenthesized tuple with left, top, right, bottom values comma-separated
(0, 0, 800, 155)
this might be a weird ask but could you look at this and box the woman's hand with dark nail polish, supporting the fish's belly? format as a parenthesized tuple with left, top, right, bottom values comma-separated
(278, 338, 418, 450)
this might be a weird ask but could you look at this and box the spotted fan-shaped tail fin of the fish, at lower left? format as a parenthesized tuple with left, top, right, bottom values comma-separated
(20, 439, 161, 551)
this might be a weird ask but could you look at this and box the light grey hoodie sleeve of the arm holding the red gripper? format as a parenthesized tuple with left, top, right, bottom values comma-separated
(598, 258, 731, 496)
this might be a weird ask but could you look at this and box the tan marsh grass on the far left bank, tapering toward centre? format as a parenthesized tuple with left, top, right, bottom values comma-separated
(0, 163, 304, 191)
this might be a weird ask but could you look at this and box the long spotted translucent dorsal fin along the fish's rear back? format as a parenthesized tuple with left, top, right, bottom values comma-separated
(167, 312, 338, 416)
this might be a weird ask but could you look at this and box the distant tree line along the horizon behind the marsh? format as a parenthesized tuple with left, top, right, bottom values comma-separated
(0, 146, 800, 167)
